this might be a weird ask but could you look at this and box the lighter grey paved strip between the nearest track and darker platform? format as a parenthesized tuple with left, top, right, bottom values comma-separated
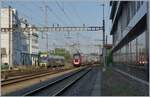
(62, 66, 101, 96)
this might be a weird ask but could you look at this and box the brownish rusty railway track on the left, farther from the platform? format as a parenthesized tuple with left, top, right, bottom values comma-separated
(1, 69, 72, 87)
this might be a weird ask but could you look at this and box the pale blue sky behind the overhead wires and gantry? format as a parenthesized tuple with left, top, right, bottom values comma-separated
(1, 0, 112, 53)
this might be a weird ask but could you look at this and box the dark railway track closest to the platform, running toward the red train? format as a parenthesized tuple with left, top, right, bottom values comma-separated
(23, 67, 91, 96)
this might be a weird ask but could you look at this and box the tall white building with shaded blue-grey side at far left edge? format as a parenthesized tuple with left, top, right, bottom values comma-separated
(0, 8, 21, 67)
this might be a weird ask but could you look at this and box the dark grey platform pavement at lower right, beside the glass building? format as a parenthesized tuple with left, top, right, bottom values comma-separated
(101, 67, 149, 96)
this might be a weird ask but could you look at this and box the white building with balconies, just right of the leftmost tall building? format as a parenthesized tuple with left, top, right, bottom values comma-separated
(20, 19, 39, 65)
